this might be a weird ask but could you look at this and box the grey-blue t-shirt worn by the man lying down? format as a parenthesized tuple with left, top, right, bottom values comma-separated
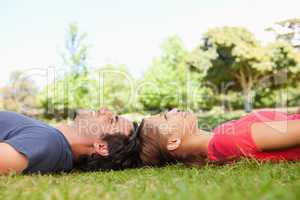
(0, 111, 73, 173)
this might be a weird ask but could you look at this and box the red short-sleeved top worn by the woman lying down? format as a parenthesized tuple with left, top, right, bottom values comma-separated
(208, 111, 300, 162)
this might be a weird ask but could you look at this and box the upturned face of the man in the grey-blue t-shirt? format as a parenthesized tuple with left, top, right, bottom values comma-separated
(74, 108, 134, 137)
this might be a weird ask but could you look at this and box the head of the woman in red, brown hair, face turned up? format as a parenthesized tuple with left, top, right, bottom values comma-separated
(140, 109, 209, 166)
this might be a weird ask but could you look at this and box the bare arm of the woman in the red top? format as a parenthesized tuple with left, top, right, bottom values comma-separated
(251, 120, 300, 151)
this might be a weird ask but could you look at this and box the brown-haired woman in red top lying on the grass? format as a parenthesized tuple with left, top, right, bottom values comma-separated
(139, 109, 300, 166)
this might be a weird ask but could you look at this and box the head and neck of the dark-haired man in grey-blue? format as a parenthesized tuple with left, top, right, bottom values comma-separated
(59, 108, 143, 171)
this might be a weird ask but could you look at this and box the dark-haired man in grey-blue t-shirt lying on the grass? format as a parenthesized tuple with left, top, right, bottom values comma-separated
(0, 109, 138, 174)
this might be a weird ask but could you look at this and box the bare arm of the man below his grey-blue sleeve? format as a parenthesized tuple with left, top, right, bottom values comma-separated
(0, 143, 28, 175)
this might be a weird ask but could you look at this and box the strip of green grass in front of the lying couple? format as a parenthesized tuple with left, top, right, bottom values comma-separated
(0, 160, 300, 200)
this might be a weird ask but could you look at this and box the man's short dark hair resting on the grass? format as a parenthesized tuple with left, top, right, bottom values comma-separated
(74, 123, 141, 171)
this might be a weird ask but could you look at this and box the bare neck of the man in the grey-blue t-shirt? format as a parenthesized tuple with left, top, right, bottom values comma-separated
(57, 124, 95, 162)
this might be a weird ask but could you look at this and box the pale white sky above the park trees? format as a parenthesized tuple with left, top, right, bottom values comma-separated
(0, 0, 300, 86)
